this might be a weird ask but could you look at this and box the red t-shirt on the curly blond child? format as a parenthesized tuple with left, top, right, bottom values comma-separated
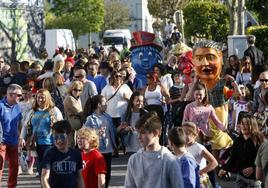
(82, 149, 106, 188)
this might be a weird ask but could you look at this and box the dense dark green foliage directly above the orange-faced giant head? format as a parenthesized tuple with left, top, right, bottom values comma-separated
(183, 1, 229, 41)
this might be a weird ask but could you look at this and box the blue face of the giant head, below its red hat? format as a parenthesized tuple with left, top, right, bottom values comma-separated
(130, 46, 162, 85)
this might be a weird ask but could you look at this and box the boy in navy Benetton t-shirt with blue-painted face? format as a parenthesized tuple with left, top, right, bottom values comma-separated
(41, 120, 84, 188)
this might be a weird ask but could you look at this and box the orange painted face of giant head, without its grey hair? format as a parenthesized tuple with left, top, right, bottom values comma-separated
(193, 48, 222, 80)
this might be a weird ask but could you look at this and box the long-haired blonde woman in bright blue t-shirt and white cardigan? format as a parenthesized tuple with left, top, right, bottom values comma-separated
(20, 89, 63, 175)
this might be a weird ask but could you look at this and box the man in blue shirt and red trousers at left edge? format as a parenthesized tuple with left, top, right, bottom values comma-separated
(0, 84, 22, 188)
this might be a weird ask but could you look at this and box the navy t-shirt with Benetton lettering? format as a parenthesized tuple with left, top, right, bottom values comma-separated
(41, 147, 82, 188)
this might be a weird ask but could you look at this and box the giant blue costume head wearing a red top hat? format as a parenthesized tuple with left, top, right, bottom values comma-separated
(130, 31, 162, 85)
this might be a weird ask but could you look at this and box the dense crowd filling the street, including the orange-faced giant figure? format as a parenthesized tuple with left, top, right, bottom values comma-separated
(0, 32, 268, 188)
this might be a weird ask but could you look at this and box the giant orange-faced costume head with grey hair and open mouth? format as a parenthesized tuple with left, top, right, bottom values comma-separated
(193, 41, 222, 82)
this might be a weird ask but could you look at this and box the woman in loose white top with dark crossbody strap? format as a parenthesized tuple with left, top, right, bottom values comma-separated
(101, 71, 132, 151)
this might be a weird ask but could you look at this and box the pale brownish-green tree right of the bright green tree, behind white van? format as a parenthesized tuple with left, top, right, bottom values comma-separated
(103, 0, 130, 31)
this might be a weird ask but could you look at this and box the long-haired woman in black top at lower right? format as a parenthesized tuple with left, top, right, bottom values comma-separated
(219, 112, 264, 188)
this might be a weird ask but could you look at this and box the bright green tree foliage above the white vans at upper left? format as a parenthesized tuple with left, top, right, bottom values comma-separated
(46, 0, 104, 38)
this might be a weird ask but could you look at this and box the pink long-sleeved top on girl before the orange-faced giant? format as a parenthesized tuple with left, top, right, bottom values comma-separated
(183, 102, 226, 136)
